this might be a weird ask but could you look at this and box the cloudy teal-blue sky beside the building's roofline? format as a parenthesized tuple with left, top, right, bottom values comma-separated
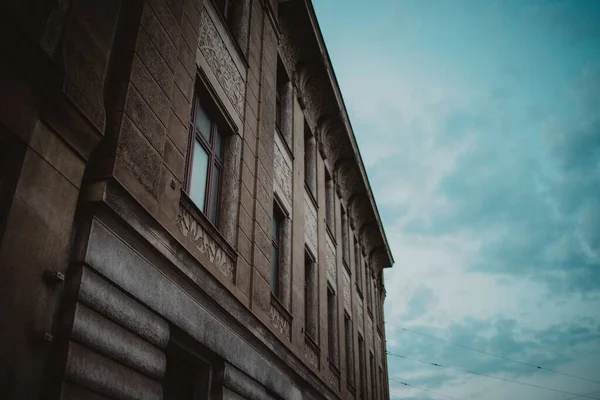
(314, 0, 600, 400)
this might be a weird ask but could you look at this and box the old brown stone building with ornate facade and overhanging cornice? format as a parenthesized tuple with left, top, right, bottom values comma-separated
(0, 0, 393, 400)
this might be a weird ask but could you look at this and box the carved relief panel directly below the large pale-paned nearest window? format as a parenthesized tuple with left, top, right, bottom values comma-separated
(177, 204, 235, 281)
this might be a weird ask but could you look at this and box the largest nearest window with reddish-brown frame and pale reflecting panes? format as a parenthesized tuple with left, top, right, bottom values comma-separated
(187, 96, 223, 225)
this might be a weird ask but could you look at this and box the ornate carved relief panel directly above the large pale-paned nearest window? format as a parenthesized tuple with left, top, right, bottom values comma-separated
(199, 7, 245, 117)
